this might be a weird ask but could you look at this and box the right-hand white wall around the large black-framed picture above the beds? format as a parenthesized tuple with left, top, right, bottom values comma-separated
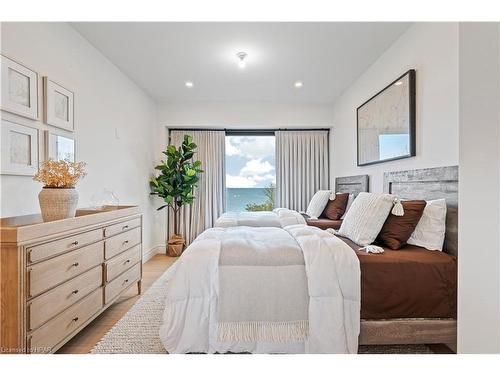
(330, 23, 458, 192)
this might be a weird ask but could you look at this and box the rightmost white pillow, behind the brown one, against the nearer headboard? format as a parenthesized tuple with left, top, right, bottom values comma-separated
(407, 199, 446, 251)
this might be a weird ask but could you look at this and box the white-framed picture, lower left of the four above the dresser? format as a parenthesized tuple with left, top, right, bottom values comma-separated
(0, 120, 38, 176)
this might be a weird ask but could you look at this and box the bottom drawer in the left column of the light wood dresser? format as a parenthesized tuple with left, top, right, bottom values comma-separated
(28, 288, 102, 353)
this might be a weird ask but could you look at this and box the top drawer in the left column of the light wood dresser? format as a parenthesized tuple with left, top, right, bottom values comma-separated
(28, 229, 103, 263)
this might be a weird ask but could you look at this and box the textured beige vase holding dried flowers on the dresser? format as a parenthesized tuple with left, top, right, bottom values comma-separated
(38, 188, 78, 221)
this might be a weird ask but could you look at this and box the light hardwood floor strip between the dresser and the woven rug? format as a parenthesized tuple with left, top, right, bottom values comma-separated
(57, 254, 177, 354)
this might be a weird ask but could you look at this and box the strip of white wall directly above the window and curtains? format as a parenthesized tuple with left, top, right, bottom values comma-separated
(158, 102, 332, 128)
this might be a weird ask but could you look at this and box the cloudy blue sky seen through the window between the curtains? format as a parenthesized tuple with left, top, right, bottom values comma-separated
(226, 136, 276, 188)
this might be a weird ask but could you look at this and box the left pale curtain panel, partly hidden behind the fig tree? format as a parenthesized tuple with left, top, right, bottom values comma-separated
(168, 130, 226, 244)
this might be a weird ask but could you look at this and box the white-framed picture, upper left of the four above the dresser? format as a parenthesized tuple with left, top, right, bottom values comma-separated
(0, 55, 38, 120)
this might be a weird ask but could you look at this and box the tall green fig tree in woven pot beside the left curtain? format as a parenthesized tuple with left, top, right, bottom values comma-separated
(150, 135, 203, 256)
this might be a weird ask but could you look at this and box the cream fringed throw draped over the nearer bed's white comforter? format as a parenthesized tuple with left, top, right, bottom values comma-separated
(218, 227, 309, 342)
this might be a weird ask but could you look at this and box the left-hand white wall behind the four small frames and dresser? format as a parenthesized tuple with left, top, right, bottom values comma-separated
(1, 23, 164, 258)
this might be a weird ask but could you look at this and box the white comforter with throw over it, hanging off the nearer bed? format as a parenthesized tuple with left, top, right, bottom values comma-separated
(160, 225, 361, 353)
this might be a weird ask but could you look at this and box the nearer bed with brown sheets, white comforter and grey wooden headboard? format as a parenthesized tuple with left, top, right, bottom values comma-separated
(160, 167, 458, 353)
